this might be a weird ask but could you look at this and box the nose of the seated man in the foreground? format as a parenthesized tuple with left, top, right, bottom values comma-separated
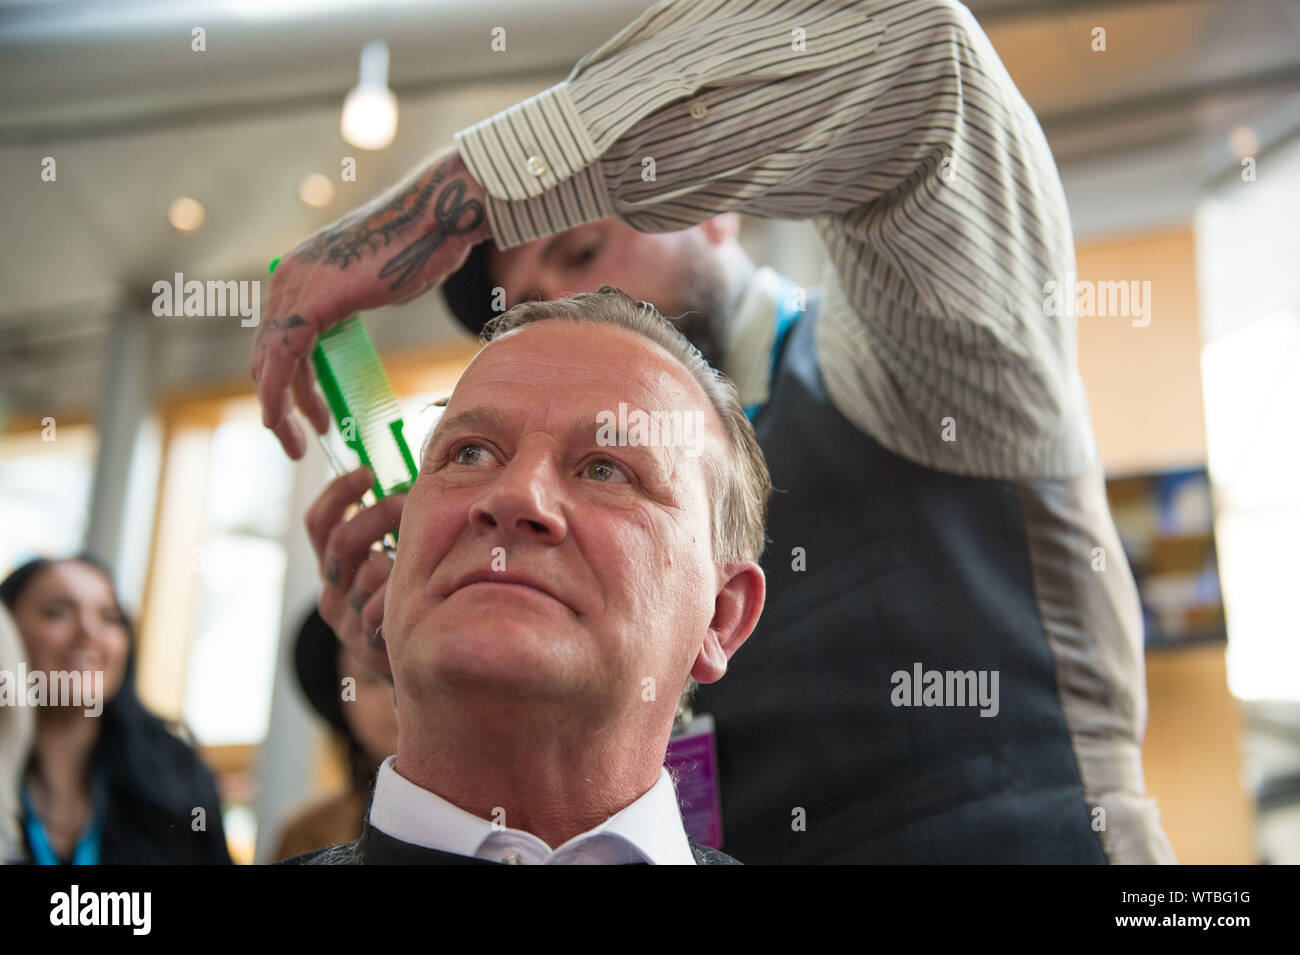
(469, 450, 568, 544)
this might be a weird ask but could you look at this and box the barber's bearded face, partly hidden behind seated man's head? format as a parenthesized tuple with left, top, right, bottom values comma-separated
(488, 216, 738, 368)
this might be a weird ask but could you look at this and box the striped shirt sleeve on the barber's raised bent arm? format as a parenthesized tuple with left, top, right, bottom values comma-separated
(456, 0, 1096, 478)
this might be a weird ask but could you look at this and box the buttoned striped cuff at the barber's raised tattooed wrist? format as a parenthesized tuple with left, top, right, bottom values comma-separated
(455, 82, 614, 249)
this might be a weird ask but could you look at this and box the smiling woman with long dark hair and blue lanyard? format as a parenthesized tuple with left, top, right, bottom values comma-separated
(0, 556, 230, 865)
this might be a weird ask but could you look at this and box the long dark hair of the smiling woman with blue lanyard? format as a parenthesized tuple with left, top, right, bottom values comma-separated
(0, 554, 222, 861)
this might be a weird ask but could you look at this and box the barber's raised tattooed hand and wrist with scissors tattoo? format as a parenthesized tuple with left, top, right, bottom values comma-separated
(248, 147, 491, 459)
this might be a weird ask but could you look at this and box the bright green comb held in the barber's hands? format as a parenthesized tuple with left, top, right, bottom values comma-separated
(269, 259, 416, 498)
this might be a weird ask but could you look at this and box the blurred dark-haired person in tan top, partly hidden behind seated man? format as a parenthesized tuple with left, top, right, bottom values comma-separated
(274, 611, 398, 859)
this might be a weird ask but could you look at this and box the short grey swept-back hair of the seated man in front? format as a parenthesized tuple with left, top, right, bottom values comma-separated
(480, 285, 772, 713)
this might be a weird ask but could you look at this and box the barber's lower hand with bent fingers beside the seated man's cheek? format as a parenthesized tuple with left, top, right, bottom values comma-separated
(306, 468, 406, 674)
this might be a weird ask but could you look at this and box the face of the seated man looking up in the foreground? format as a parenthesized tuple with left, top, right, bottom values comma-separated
(384, 321, 723, 720)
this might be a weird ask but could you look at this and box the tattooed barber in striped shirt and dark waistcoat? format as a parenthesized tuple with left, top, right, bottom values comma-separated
(252, 0, 1174, 863)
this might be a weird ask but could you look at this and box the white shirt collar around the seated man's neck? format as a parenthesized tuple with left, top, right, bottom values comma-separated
(371, 756, 696, 865)
